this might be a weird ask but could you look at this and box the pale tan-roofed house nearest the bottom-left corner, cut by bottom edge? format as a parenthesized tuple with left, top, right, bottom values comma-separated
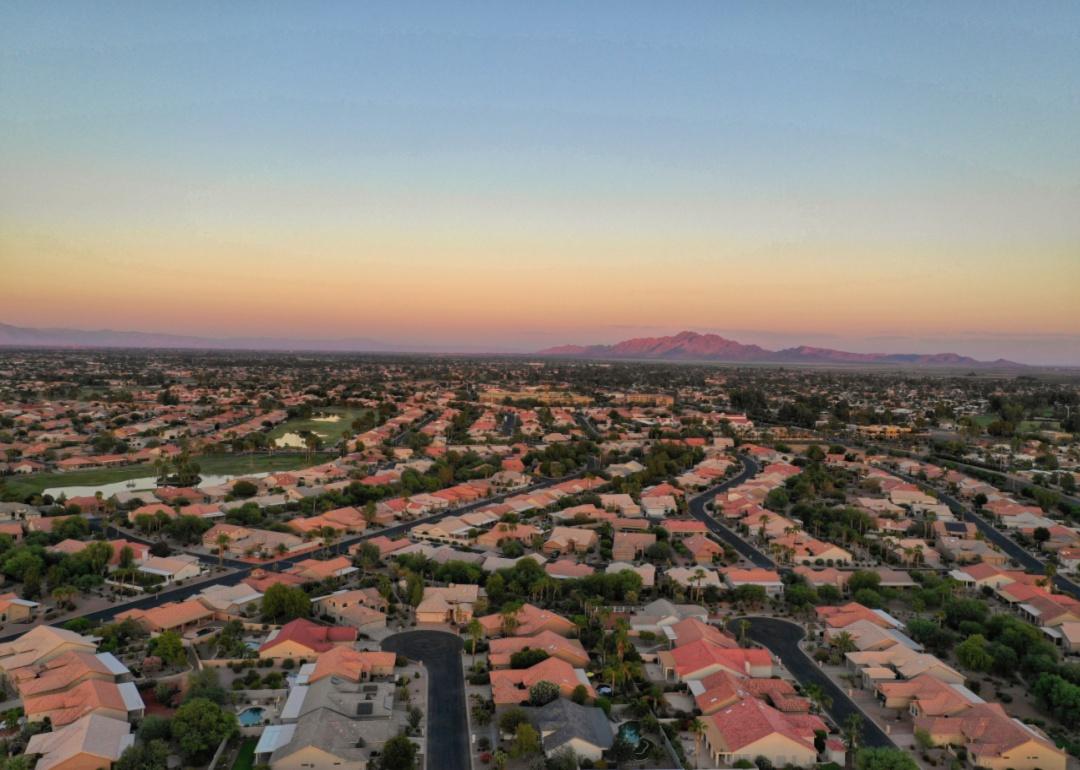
(26, 714, 135, 770)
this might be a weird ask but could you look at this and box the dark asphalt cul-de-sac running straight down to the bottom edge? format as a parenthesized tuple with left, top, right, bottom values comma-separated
(382, 631, 472, 770)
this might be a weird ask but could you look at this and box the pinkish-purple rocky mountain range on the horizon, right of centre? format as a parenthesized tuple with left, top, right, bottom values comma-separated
(537, 332, 1024, 367)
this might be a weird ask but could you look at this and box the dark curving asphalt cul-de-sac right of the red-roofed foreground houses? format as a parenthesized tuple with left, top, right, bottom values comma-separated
(728, 618, 896, 748)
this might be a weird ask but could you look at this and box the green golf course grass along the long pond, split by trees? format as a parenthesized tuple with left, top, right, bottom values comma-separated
(2, 451, 333, 500)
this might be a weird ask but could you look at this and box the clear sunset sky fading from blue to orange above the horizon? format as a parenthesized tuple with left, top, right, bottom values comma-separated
(6, 0, 1080, 365)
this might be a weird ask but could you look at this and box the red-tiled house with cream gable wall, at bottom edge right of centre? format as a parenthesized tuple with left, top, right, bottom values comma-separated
(703, 698, 827, 767)
